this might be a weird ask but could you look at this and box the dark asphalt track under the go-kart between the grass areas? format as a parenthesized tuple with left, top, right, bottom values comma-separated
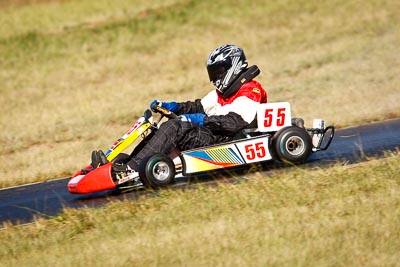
(0, 119, 400, 228)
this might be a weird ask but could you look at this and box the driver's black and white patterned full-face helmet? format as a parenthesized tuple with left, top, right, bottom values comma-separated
(207, 44, 247, 94)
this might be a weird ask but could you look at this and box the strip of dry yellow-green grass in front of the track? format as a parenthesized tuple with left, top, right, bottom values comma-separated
(0, 152, 400, 266)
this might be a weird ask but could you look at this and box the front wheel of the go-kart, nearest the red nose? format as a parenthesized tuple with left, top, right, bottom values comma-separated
(139, 154, 175, 189)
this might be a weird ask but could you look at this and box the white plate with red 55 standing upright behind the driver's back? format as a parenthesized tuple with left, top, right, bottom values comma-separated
(257, 102, 292, 132)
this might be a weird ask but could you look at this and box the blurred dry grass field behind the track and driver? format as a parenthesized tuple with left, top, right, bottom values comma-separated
(0, 0, 400, 187)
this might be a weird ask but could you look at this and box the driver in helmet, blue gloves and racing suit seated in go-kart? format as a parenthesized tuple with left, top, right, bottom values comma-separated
(92, 44, 267, 182)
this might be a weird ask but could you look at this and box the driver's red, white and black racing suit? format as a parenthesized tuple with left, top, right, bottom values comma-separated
(128, 80, 267, 169)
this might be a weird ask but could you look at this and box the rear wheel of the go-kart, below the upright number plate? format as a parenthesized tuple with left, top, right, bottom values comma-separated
(271, 126, 312, 164)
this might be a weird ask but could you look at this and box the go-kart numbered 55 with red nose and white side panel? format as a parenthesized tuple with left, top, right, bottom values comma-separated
(68, 102, 335, 194)
